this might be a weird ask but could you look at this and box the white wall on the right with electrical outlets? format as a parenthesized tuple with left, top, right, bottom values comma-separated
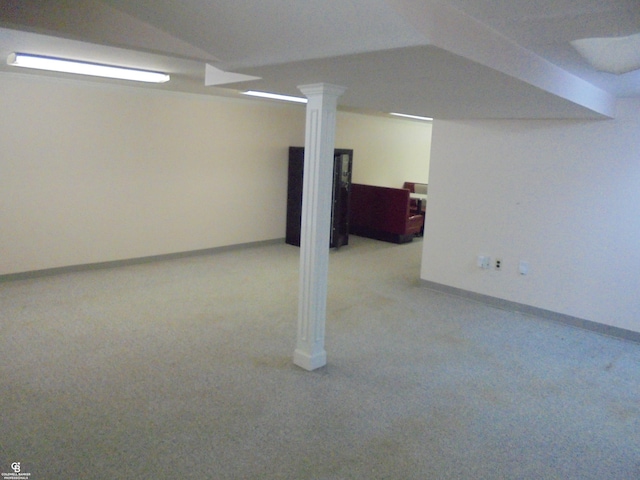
(421, 99, 640, 331)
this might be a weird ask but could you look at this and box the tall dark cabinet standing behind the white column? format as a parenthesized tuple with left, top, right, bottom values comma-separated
(285, 147, 353, 248)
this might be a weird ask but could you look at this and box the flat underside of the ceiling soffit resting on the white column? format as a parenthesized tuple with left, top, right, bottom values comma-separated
(229, 46, 603, 119)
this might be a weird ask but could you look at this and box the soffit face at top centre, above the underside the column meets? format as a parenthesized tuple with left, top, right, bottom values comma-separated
(101, 0, 425, 70)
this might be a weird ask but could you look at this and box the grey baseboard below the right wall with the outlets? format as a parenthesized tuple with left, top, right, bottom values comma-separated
(422, 280, 640, 343)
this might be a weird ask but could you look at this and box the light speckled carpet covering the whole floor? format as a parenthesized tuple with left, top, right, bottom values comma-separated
(0, 237, 640, 480)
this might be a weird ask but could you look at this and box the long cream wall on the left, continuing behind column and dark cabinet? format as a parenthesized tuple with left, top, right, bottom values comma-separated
(0, 74, 432, 275)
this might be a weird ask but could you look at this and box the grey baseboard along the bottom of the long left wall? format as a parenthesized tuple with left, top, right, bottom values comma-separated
(0, 238, 284, 283)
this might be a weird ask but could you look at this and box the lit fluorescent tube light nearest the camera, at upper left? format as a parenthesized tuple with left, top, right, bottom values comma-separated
(7, 53, 170, 83)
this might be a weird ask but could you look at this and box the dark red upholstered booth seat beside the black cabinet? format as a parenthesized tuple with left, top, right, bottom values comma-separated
(349, 183, 424, 243)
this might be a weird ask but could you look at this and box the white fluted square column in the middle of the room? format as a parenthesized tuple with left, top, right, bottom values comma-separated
(293, 83, 346, 370)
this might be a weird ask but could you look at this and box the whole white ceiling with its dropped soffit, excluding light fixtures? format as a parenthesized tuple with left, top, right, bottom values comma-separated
(0, 0, 640, 118)
